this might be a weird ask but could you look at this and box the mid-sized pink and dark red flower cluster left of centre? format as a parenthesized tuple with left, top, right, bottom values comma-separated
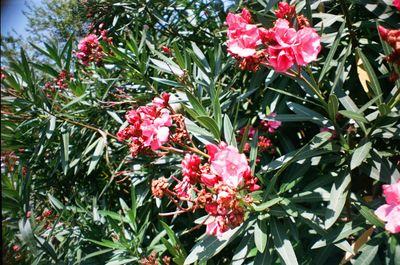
(117, 93, 172, 157)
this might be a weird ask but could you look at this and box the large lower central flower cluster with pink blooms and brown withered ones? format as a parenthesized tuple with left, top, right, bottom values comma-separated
(152, 142, 260, 237)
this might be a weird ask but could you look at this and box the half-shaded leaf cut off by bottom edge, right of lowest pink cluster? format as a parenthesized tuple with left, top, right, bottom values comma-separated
(271, 218, 298, 265)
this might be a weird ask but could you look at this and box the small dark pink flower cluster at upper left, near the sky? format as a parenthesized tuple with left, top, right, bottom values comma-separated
(76, 34, 103, 66)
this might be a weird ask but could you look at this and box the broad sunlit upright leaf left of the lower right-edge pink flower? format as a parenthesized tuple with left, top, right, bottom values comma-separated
(325, 170, 351, 229)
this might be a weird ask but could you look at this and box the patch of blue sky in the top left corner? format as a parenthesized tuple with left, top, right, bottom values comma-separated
(1, 0, 41, 37)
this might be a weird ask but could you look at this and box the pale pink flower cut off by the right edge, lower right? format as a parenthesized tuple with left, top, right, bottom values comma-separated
(375, 179, 400, 234)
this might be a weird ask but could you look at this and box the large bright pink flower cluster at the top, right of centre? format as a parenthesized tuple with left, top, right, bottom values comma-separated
(226, 2, 321, 72)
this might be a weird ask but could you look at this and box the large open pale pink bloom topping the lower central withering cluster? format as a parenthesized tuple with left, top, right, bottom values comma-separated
(206, 142, 249, 188)
